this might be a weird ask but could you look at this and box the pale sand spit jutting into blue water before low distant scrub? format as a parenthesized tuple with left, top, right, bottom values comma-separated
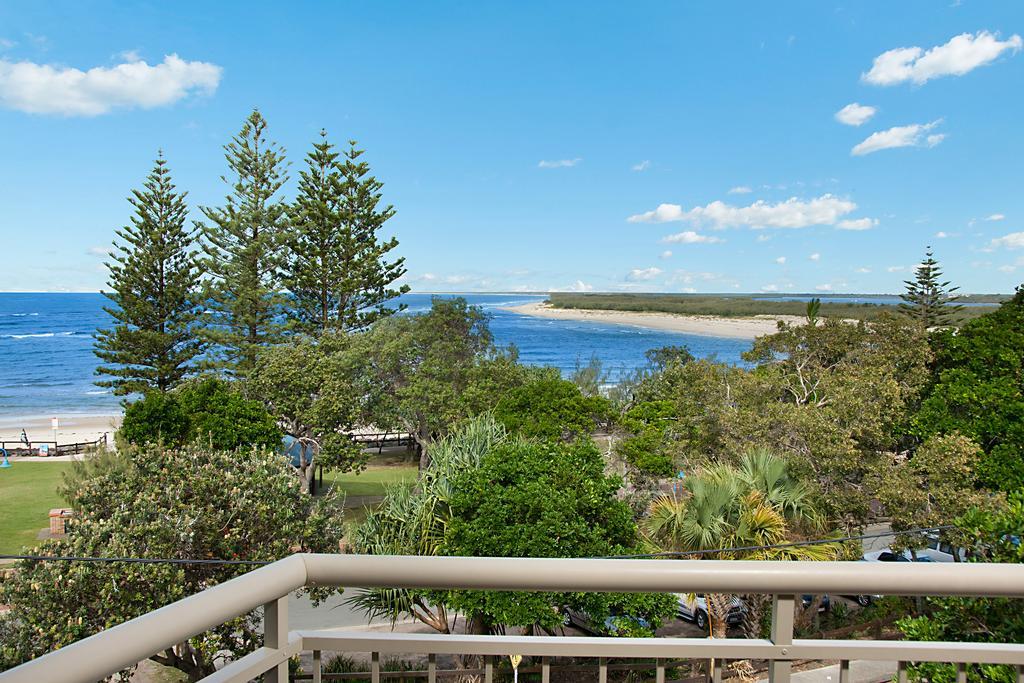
(505, 303, 803, 339)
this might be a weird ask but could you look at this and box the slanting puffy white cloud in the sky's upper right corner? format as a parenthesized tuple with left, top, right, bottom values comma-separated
(860, 31, 1024, 85)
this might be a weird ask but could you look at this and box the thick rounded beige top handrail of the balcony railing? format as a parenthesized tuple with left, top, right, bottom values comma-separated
(0, 554, 1024, 683)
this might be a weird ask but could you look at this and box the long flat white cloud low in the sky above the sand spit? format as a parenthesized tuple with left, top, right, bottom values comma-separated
(627, 195, 857, 229)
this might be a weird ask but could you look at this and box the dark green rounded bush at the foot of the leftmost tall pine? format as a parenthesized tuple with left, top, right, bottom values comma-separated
(118, 377, 283, 451)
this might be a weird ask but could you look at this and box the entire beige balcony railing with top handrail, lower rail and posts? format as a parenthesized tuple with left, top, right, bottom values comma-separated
(0, 554, 1024, 683)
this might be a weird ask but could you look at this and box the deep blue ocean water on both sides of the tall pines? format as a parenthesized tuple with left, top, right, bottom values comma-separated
(0, 293, 751, 419)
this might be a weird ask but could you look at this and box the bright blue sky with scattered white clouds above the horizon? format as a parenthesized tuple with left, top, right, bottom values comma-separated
(0, 0, 1024, 292)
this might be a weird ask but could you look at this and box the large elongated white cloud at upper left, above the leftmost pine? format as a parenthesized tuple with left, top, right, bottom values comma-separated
(0, 54, 223, 116)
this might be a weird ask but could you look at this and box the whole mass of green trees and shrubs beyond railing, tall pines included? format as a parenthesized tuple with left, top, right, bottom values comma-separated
(0, 112, 1024, 680)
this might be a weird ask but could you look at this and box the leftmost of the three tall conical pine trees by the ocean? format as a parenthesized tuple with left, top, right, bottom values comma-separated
(95, 155, 203, 396)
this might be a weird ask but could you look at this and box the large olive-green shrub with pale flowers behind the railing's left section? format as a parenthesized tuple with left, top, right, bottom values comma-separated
(0, 445, 341, 680)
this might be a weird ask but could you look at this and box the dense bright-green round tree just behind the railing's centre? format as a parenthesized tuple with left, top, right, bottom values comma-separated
(441, 440, 674, 630)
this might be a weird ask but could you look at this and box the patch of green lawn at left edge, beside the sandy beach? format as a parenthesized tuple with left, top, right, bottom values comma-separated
(0, 463, 72, 555)
